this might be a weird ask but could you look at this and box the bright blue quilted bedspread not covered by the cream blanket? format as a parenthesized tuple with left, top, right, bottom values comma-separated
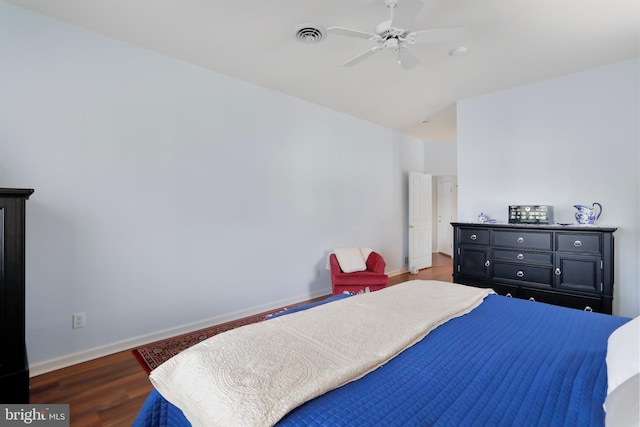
(134, 295, 629, 427)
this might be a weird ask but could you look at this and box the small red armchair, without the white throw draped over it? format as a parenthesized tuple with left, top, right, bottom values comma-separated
(329, 252, 389, 295)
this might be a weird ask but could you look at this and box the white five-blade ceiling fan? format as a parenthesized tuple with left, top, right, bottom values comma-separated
(327, 0, 467, 69)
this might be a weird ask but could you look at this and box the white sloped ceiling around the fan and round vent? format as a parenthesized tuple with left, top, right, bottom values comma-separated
(8, 0, 640, 141)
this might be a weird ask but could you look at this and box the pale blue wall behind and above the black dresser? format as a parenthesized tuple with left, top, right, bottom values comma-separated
(457, 59, 640, 316)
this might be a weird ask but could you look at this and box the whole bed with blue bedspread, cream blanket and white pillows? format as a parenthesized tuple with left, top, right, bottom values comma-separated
(134, 280, 638, 427)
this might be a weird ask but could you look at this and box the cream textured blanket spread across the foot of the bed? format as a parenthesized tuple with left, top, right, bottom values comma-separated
(150, 280, 493, 427)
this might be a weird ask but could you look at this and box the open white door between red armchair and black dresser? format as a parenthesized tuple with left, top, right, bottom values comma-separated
(409, 172, 432, 273)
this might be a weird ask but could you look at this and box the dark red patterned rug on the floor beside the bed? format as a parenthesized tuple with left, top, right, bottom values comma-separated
(131, 296, 326, 375)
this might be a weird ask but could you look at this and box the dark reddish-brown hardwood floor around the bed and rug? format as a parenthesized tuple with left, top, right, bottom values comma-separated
(31, 254, 453, 427)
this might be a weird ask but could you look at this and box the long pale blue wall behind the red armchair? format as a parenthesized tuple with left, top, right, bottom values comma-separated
(0, 1, 424, 374)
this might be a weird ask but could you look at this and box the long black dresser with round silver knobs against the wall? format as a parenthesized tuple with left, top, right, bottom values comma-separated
(452, 223, 616, 314)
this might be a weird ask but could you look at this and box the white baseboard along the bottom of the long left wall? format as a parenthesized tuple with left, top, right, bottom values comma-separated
(29, 290, 330, 377)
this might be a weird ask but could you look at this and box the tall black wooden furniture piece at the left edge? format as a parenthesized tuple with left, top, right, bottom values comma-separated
(0, 188, 33, 403)
